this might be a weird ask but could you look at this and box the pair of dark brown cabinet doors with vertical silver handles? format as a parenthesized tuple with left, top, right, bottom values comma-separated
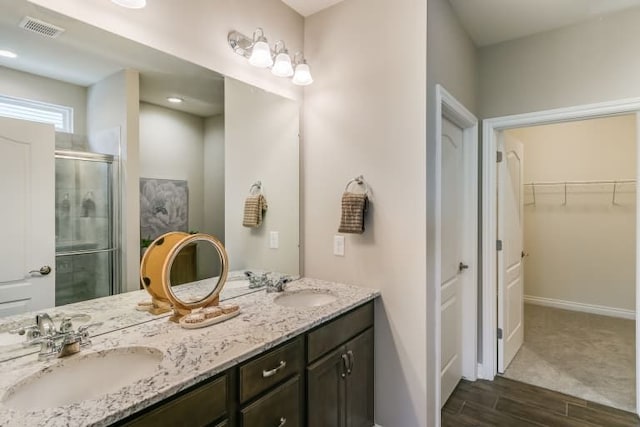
(307, 328, 373, 427)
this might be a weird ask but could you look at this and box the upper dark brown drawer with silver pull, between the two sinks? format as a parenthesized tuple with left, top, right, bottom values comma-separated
(240, 337, 304, 403)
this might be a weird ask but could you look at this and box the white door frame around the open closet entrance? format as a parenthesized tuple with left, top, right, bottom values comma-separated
(478, 98, 640, 414)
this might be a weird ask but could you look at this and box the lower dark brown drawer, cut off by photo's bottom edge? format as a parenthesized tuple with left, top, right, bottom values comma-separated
(240, 375, 301, 427)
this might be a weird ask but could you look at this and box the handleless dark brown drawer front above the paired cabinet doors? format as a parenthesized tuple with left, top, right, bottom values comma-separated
(307, 302, 373, 363)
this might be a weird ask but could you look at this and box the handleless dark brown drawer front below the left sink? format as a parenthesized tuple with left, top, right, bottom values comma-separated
(124, 374, 227, 427)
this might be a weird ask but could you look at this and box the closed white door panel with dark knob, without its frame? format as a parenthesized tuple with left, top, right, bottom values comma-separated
(440, 117, 469, 405)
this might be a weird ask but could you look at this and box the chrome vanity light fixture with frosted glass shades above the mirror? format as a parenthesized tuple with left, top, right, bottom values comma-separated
(227, 28, 313, 86)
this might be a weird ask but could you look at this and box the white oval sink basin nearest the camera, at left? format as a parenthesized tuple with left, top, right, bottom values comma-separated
(2, 347, 162, 410)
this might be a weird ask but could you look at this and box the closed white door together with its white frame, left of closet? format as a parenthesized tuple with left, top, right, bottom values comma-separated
(434, 85, 478, 413)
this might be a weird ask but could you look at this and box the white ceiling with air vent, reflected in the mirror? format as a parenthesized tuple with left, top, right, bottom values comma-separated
(0, 0, 224, 117)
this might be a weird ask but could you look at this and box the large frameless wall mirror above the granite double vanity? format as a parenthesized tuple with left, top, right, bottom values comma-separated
(0, 0, 299, 352)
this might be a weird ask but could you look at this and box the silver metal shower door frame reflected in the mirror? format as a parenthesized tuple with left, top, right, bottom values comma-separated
(55, 150, 122, 295)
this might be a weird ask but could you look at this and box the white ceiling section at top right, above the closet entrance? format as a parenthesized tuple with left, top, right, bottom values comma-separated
(449, 0, 640, 46)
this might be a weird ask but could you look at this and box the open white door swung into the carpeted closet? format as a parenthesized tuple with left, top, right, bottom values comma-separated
(498, 133, 524, 373)
